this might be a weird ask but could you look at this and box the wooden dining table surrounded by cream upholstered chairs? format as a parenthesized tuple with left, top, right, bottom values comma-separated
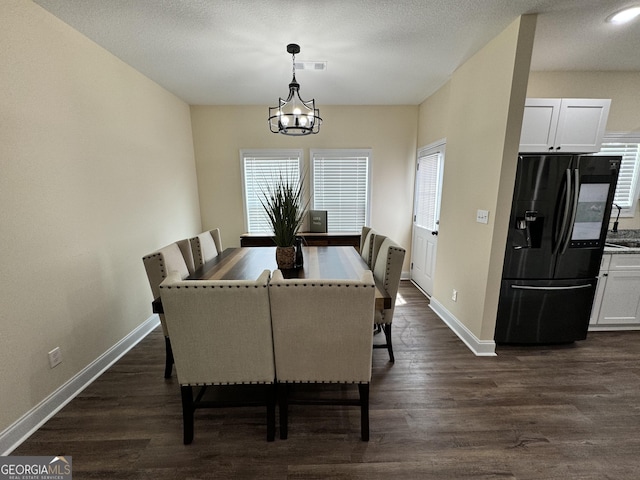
(153, 246, 391, 313)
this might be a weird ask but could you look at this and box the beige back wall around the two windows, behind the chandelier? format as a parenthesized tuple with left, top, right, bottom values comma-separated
(191, 104, 418, 266)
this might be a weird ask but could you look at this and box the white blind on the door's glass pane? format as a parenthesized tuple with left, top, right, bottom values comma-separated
(414, 152, 440, 230)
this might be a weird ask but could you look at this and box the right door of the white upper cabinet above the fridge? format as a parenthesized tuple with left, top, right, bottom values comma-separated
(554, 98, 611, 153)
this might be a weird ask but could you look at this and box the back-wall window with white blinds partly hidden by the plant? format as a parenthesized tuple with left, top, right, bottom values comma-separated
(240, 150, 302, 233)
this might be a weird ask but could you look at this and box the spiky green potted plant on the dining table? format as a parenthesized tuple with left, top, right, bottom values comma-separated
(260, 174, 306, 270)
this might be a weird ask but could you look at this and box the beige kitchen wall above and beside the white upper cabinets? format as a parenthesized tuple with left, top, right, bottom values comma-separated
(527, 72, 640, 229)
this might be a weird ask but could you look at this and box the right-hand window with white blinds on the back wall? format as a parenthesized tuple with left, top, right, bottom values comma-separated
(311, 150, 371, 232)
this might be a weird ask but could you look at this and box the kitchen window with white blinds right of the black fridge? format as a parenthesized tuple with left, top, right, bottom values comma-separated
(596, 133, 640, 216)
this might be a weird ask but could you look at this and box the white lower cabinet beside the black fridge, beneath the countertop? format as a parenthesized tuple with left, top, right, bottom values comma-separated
(589, 253, 640, 331)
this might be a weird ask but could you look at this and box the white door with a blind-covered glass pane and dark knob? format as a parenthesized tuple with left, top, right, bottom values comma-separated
(411, 142, 445, 295)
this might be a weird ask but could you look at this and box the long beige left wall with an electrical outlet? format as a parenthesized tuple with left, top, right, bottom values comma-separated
(0, 0, 200, 431)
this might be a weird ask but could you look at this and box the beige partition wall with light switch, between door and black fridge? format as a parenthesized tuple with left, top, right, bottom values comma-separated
(419, 16, 536, 341)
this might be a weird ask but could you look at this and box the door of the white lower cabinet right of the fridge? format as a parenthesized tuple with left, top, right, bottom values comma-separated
(597, 270, 640, 325)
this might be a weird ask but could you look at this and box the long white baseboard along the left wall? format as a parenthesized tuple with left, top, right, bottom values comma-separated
(0, 314, 160, 455)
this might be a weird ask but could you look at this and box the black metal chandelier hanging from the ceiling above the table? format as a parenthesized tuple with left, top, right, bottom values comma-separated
(269, 43, 322, 136)
